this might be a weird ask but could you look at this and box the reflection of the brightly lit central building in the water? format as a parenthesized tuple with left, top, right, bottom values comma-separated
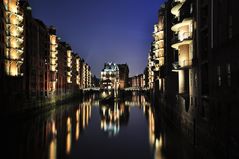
(100, 102, 129, 136)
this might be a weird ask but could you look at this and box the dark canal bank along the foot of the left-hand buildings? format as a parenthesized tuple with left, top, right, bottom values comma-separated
(1, 90, 86, 118)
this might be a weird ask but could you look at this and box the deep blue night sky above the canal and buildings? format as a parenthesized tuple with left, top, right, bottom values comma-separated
(29, 0, 163, 77)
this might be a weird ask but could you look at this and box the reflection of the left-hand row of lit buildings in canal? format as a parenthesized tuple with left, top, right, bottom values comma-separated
(5, 101, 91, 159)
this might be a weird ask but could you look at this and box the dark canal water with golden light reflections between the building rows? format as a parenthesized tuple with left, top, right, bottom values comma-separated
(2, 96, 198, 159)
